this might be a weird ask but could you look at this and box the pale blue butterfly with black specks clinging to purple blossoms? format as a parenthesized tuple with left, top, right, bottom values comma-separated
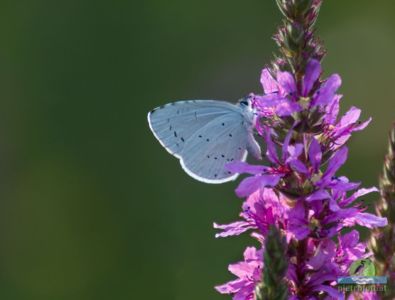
(148, 98, 261, 184)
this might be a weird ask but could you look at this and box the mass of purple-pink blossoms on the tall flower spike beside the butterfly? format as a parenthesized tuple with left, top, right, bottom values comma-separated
(214, 59, 387, 300)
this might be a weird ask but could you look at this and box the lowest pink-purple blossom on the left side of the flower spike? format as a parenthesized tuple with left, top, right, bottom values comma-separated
(215, 247, 263, 300)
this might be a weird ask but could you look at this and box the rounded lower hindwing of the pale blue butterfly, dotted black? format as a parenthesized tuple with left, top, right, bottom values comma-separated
(180, 112, 252, 183)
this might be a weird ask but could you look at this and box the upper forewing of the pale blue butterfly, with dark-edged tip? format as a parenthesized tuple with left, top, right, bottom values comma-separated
(148, 100, 238, 158)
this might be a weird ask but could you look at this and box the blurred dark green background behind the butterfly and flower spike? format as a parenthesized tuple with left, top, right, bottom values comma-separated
(0, 0, 395, 300)
